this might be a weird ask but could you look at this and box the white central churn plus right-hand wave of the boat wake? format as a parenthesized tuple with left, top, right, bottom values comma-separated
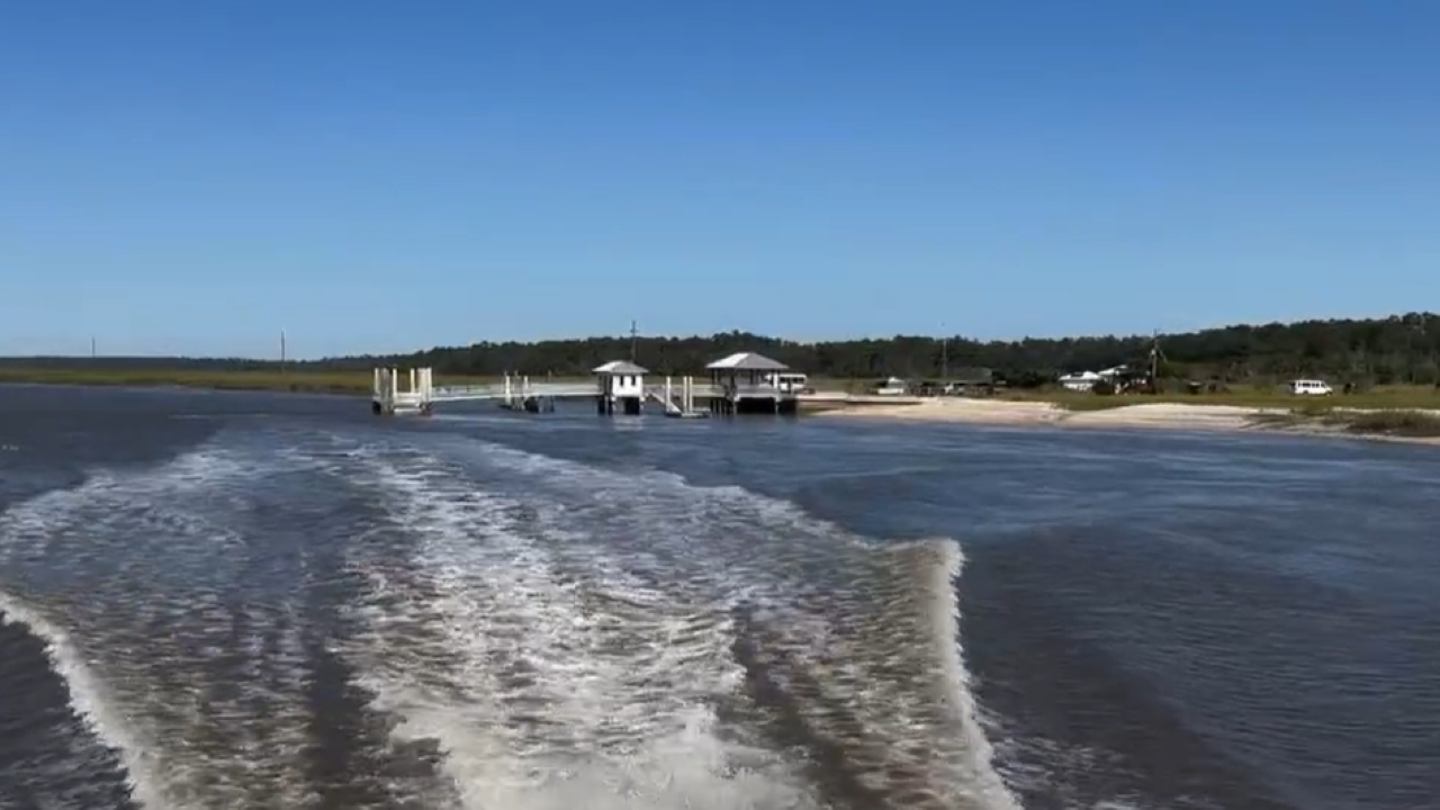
(345, 444, 1017, 810)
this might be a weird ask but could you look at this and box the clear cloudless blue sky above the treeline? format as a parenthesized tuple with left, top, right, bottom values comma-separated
(0, 0, 1440, 356)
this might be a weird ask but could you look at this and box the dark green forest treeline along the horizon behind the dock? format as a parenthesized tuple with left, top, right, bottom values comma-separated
(11, 313, 1440, 385)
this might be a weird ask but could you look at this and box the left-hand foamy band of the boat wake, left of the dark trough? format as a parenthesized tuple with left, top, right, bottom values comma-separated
(0, 445, 329, 807)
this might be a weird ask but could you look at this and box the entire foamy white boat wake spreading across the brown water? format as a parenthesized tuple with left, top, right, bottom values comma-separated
(0, 431, 1015, 810)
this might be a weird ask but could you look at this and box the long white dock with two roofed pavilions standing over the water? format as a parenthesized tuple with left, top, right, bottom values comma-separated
(370, 352, 799, 418)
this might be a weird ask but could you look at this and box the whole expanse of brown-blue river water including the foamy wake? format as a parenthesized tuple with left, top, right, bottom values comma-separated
(0, 388, 1440, 810)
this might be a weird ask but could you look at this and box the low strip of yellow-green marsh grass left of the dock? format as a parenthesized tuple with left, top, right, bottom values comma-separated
(0, 366, 494, 395)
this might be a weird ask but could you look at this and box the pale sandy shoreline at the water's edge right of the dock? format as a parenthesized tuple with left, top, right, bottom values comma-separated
(812, 398, 1440, 447)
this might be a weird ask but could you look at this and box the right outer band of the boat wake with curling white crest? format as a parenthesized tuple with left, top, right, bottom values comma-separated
(484, 447, 1018, 809)
